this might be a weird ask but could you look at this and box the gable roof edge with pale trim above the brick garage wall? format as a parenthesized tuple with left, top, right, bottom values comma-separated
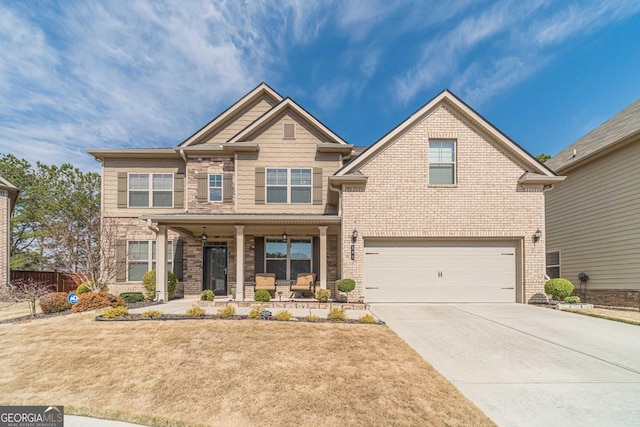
(335, 89, 557, 181)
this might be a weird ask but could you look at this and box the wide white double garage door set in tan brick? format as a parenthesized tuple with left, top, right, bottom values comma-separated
(364, 240, 516, 302)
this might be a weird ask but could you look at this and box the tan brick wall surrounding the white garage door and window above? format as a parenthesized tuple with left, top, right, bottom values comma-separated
(341, 106, 545, 302)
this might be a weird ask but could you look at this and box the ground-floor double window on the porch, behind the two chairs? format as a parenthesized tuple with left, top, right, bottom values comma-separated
(265, 239, 311, 280)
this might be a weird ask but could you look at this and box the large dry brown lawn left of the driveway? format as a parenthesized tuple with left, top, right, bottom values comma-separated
(0, 315, 493, 426)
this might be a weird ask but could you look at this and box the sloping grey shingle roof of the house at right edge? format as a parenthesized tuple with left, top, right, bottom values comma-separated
(545, 99, 640, 172)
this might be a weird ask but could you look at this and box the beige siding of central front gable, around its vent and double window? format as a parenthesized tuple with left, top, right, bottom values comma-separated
(236, 110, 341, 214)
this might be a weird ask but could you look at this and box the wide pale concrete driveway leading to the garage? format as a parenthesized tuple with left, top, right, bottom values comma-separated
(371, 304, 640, 427)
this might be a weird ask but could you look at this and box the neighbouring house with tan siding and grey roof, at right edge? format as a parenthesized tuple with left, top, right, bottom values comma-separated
(545, 100, 640, 306)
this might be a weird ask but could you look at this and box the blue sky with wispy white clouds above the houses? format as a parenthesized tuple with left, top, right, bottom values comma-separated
(0, 0, 640, 170)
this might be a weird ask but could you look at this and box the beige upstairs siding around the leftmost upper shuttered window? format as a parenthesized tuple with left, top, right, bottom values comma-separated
(102, 159, 185, 217)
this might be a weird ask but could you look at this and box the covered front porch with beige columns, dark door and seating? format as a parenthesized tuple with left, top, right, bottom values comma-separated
(143, 214, 341, 301)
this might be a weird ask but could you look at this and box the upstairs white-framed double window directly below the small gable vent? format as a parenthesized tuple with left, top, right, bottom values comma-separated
(266, 168, 313, 204)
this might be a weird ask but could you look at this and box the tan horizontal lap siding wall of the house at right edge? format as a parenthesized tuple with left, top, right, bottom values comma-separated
(546, 141, 640, 289)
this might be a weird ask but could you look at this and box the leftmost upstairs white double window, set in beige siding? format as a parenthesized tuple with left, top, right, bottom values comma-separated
(129, 173, 173, 208)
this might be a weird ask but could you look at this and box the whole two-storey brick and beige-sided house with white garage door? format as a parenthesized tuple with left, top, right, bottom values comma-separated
(90, 83, 561, 302)
